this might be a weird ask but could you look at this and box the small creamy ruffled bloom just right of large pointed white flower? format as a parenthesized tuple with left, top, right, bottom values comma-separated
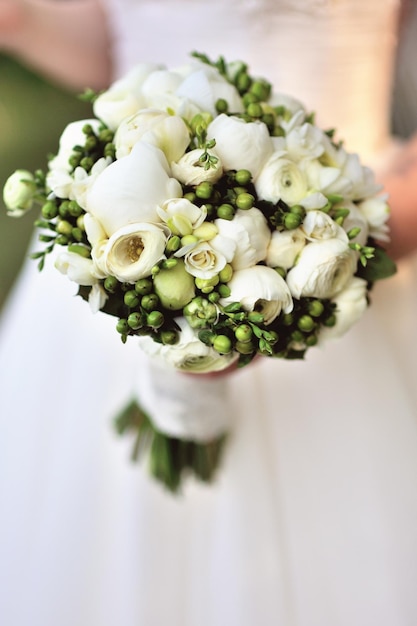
(157, 198, 207, 237)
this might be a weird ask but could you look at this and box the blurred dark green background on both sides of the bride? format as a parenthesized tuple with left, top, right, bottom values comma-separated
(0, 0, 417, 310)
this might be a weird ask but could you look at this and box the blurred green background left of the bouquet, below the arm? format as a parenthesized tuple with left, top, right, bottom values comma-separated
(0, 55, 91, 308)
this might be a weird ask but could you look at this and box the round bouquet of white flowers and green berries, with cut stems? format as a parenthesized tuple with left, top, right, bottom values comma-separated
(4, 53, 395, 489)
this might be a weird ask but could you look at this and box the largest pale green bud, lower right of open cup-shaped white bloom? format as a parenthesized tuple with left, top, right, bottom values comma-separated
(154, 259, 195, 311)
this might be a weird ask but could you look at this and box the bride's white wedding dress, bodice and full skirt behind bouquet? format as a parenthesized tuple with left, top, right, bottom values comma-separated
(0, 0, 417, 626)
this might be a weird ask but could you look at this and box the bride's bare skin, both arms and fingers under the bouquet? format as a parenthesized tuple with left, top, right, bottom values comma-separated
(0, 0, 417, 376)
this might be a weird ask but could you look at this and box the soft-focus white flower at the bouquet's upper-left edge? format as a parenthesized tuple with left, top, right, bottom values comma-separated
(93, 63, 160, 130)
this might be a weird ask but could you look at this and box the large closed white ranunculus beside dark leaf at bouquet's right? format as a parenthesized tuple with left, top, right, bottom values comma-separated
(286, 239, 357, 298)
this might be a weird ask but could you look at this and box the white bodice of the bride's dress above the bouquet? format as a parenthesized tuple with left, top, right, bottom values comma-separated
(107, 0, 400, 161)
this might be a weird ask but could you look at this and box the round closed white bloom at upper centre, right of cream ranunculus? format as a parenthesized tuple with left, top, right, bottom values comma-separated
(207, 113, 273, 178)
